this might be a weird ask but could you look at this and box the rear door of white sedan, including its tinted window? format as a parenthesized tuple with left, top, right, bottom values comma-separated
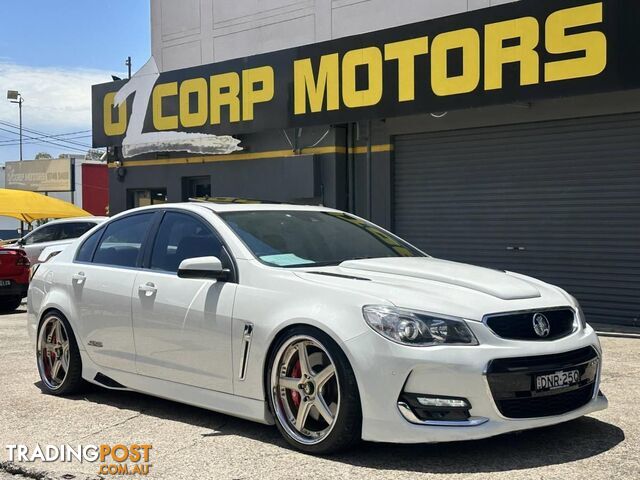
(71, 212, 158, 372)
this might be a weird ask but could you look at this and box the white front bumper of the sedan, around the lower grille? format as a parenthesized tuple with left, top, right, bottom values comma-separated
(347, 322, 608, 443)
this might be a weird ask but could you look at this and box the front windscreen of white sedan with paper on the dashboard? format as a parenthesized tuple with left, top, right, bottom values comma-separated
(220, 210, 425, 268)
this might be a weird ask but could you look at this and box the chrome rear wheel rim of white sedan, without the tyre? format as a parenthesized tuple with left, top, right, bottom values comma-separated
(37, 316, 71, 390)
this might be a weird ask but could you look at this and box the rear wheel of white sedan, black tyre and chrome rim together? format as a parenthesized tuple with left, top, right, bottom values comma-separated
(36, 312, 83, 396)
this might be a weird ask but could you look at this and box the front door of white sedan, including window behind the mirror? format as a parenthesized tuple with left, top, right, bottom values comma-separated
(132, 210, 237, 392)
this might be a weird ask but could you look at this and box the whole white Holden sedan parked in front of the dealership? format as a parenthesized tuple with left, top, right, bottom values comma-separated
(28, 203, 607, 454)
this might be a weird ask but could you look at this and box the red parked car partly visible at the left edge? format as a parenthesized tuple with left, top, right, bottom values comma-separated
(0, 248, 30, 312)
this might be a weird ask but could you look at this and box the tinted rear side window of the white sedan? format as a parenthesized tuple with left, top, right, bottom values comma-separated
(93, 213, 154, 268)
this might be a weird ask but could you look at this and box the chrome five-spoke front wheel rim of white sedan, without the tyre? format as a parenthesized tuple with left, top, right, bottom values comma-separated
(271, 336, 340, 445)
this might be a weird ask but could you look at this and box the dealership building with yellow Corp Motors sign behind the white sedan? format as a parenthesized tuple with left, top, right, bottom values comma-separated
(93, 0, 640, 329)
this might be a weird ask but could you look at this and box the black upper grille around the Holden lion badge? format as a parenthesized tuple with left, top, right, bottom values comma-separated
(485, 308, 577, 341)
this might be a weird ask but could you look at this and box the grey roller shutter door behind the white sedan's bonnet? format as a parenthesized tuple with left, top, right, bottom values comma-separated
(394, 114, 640, 326)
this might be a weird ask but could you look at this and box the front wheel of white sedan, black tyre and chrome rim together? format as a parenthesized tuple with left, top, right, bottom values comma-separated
(267, 327, 362, 455)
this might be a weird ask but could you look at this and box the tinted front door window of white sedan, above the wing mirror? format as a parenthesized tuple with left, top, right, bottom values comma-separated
(150, 212, 228, 273)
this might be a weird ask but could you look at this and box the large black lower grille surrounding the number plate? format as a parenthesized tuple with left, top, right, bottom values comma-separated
(487, 347, 600, 418)
